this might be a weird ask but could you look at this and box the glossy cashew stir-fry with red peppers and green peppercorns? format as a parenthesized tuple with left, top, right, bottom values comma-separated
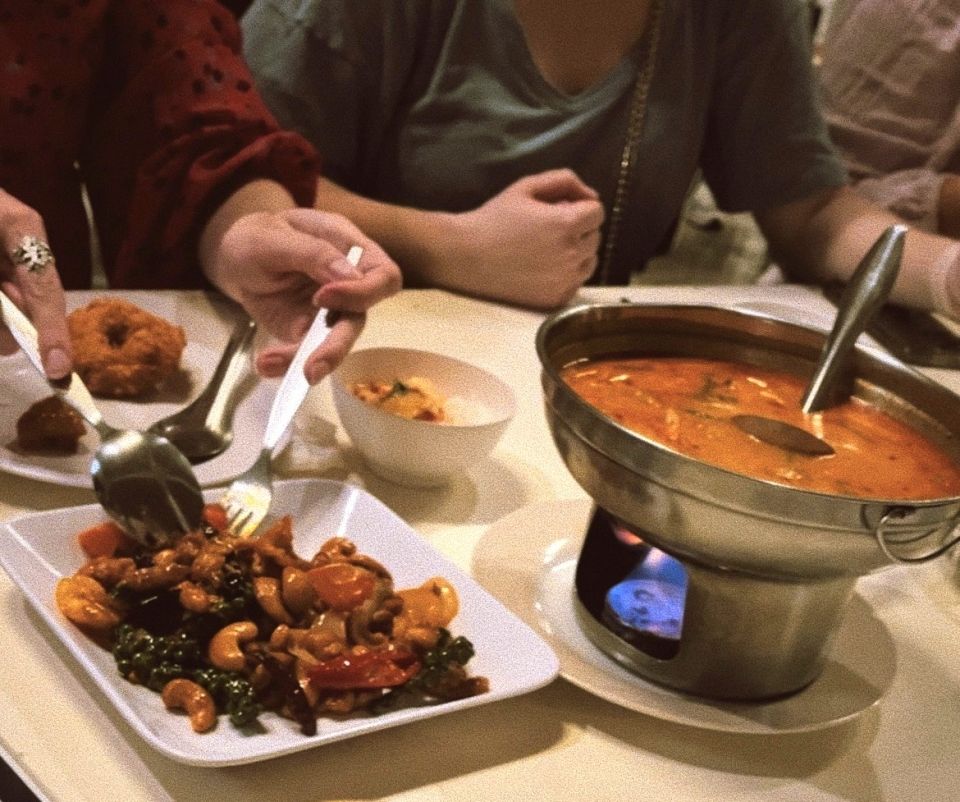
(56, 504, 488, 735)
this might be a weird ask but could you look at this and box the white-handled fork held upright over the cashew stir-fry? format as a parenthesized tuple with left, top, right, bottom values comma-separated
(220, 245, 363, 537)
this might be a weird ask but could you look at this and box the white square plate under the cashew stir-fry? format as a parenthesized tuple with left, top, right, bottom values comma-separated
(0, 479, 559, 766)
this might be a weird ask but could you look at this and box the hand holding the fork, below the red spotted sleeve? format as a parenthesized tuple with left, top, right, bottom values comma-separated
(207, 209, 401, 384)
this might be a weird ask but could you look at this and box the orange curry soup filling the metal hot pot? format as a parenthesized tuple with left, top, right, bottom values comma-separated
(562, 357, 960, 499)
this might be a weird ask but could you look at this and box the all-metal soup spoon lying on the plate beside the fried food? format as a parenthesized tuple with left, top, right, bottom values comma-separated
(147, 318, 257, 465)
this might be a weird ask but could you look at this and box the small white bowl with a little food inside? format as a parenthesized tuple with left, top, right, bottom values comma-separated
(331, 348, 516, 487)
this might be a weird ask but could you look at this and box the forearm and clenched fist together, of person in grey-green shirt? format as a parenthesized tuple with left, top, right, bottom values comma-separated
(315, 169, 603, 309)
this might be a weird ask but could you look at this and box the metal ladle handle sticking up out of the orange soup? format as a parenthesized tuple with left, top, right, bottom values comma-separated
(800, 225, 907, 412)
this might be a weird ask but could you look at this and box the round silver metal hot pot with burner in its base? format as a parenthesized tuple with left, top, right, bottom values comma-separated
(536, 304, 960, 700)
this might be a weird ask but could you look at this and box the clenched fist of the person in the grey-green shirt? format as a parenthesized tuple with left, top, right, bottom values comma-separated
(442, 169, 604, 309)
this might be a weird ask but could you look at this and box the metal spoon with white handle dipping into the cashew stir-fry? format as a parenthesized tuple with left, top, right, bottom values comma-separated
(0, 292, 203, 548)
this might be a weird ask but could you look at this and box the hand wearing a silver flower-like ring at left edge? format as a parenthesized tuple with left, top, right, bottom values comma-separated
(0, 189, 73, 379)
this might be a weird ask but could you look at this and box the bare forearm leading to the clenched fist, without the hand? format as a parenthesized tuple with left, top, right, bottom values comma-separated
(314, 178, 463, 289)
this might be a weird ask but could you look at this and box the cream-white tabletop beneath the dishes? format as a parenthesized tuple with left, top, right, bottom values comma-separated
(0, 285, 960, 802)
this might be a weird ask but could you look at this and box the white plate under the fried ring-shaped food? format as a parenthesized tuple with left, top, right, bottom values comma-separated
(0, 291, 276, 487)
